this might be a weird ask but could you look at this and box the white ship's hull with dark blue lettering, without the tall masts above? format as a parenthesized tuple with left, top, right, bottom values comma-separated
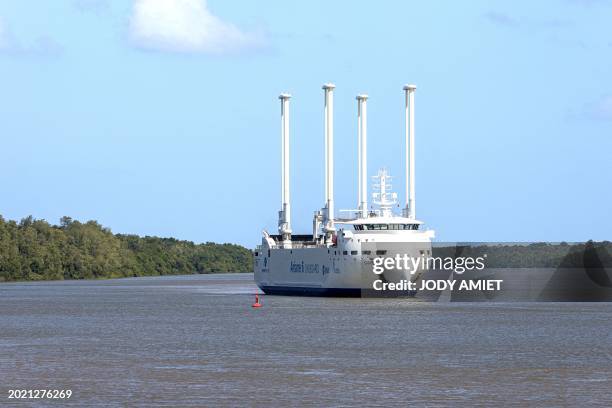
(254, 231, 431, 296)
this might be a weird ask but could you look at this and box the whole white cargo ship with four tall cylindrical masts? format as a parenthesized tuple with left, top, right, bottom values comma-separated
(254, 83, 434, 296)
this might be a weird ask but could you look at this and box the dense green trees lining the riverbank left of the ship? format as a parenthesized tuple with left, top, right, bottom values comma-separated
(0, 216, 252, 281)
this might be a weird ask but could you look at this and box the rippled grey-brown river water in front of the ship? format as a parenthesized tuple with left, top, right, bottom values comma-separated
(0, 274, 612, 406)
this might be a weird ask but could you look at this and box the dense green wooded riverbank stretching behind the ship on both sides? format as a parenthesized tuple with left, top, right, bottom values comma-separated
(0, 215, 612, 283)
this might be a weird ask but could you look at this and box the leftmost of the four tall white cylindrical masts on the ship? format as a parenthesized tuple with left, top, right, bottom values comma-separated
(278, 93, 291, 247)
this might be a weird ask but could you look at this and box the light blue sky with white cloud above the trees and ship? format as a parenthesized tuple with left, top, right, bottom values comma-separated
(0, 0, 612, 247)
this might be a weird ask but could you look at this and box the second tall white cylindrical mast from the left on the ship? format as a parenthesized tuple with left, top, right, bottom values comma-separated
(323, 83, 336, 236)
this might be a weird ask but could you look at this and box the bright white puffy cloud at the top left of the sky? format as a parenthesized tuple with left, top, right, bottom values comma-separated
(130, 0, 264, 54)
